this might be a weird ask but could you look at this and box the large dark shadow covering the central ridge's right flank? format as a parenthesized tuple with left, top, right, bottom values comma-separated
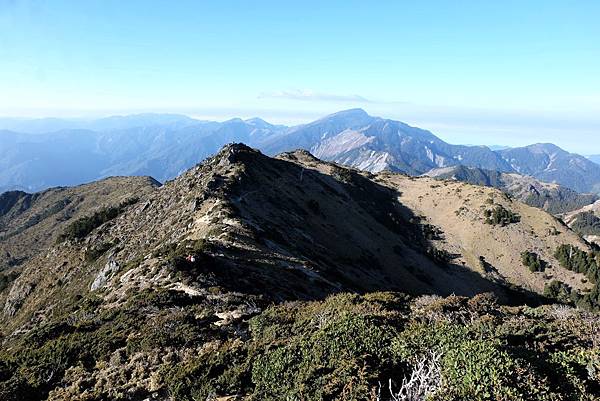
(175, 145, 543, 304)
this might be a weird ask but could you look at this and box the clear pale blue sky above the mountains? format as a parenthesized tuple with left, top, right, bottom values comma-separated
(0, 0, 600, 154)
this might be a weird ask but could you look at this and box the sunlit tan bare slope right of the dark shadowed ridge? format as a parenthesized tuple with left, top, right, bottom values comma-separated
(377, 174, 589, 293)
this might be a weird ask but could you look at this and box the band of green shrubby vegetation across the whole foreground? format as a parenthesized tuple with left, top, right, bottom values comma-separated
(0, 290, 600, 401)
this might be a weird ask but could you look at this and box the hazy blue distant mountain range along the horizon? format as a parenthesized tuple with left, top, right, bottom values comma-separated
(0, 109, 600, 192)
